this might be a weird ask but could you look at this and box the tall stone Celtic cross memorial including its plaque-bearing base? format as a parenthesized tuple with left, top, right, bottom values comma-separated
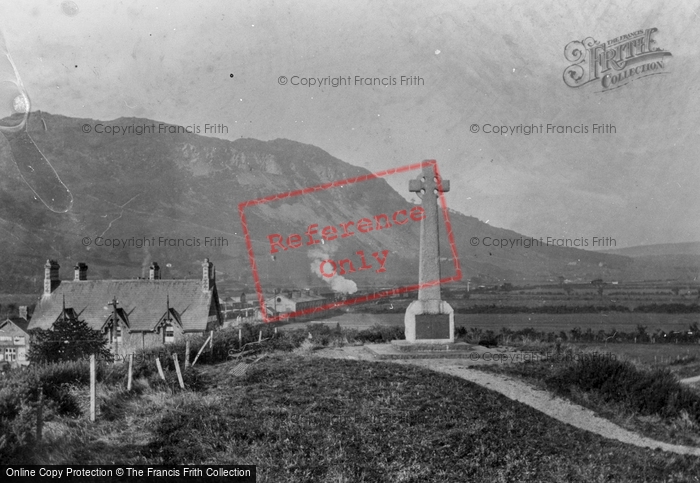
(404, 165, 455, 344)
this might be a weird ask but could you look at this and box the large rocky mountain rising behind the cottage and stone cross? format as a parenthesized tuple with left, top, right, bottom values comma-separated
(0, 112, 686, 293)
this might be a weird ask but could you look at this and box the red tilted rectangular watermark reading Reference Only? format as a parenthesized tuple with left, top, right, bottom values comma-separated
(238, 160, 462, 323)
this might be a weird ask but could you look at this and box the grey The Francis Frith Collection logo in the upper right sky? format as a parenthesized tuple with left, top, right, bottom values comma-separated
(564, 28, 672, 92)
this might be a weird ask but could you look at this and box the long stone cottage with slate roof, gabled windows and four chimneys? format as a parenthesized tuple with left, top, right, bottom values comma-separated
(29, 259, 223, 357)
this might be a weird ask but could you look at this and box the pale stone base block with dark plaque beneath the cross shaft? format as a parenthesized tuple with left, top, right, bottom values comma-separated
(404, 300, 455, 344)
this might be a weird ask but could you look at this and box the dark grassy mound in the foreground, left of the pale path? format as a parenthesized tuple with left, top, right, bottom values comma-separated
(20, 353, 700, 483)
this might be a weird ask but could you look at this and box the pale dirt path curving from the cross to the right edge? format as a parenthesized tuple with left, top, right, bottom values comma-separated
(315, 347, 700, 456)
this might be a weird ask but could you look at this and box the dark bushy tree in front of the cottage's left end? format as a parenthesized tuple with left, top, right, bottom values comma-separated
(27, 317, 110, 363)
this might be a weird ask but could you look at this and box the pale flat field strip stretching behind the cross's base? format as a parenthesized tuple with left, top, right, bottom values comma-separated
(288, 312, 700, 333)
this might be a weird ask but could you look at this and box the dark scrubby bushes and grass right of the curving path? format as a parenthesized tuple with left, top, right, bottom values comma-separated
(477, 347, 700, 447)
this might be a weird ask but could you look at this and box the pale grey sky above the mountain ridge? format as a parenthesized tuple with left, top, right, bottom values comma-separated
(0, 0, 700, 248)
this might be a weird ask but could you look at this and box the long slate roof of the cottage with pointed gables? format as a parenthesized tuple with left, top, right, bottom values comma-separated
(29, 279, 218, 332)
